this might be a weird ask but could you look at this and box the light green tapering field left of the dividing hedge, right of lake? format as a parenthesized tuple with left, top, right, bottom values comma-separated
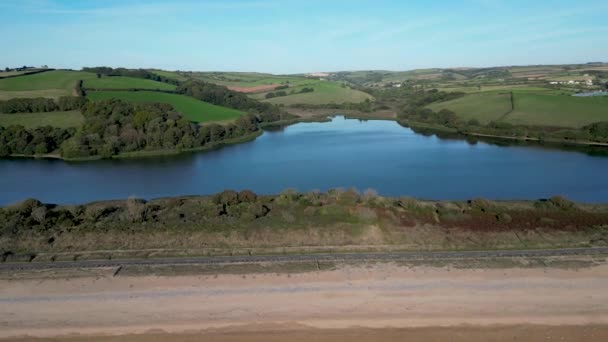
(428, 92, 511, 124)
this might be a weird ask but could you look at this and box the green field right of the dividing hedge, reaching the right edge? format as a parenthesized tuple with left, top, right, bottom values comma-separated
(505, 93, 608, 128)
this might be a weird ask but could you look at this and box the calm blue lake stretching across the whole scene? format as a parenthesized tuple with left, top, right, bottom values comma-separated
(0, 117, 608, 205)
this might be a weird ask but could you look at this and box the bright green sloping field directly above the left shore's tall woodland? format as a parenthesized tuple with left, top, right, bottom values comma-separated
(87, 91, 244, 122)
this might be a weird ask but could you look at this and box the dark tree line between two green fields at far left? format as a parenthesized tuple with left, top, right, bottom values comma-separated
(0, 96, 87, 114)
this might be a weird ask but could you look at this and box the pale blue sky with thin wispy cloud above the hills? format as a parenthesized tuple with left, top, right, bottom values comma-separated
(0, 0, 608, 73)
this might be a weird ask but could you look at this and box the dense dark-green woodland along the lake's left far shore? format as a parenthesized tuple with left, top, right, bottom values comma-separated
(0, 99, 290, 159)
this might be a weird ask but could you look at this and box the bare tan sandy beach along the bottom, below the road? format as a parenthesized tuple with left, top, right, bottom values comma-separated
(0, 264, 608, 341)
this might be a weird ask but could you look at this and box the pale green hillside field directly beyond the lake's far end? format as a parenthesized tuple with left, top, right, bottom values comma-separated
(258, 81, 374, 105)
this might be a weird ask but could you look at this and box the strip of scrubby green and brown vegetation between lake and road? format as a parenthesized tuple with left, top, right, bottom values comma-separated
(0, 189, 608, 260)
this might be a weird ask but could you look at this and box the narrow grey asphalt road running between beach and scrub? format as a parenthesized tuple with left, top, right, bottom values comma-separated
(0, 247, 608, 271)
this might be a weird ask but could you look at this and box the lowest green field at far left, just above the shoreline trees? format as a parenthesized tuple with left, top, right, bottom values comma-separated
(0, 110, 84, 128)
